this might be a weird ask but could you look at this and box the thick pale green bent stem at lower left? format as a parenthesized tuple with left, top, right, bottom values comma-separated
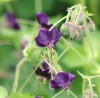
(13, 58, 26, 92)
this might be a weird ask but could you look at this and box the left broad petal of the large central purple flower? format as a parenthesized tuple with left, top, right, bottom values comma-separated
(35, 29, 50, 47)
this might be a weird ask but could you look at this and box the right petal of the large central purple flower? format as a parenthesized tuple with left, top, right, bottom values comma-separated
(51, 28, 61, 45)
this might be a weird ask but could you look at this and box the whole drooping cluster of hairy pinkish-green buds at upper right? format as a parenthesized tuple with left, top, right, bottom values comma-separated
(60, 5, 95, 39)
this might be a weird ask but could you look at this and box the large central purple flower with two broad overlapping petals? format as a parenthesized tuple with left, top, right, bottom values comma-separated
(35, 28, 61, 48)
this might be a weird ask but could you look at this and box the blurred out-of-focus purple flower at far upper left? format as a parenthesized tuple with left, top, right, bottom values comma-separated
(6, 13, 20, 30)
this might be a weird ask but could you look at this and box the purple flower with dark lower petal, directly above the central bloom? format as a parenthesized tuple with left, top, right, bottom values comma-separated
(36, 12, 52, 29)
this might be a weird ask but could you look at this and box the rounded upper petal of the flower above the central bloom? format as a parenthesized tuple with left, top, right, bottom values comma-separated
(36, 12, 48, 25)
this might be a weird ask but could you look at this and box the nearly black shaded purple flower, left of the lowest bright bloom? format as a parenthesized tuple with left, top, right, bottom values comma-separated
(35, 62, 51, 80)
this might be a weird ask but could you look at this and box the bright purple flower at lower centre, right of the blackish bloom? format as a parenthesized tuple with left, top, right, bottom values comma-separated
(50, 72, 75, 90)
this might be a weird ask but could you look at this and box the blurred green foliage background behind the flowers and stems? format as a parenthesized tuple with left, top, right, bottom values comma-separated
(0, 0, 100, 98)
